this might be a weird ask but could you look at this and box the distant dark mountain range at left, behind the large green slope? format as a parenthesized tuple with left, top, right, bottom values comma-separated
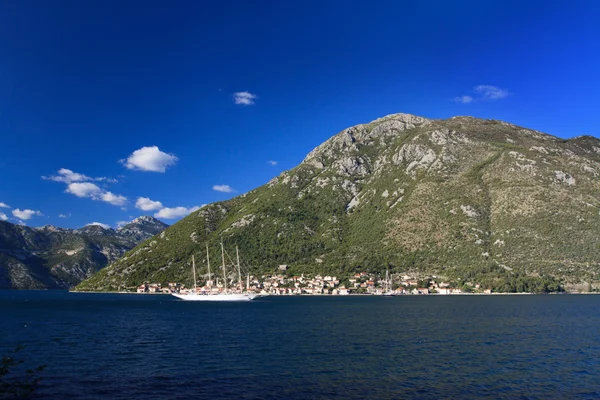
(0, 216, 168, 289)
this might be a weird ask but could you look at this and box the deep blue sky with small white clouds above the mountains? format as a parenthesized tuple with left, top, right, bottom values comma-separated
(0, 0, 600, 227)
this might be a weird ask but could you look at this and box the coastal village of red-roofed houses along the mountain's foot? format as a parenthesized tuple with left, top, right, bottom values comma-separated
(137, 265, 492, 296)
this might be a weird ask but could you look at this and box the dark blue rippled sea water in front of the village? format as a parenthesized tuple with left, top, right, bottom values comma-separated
(0, 291, 600, 399)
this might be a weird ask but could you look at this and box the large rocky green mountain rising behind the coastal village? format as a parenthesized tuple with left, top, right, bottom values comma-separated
(79, 114, 600, 291)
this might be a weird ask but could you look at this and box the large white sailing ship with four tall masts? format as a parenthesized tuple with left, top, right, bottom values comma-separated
(172, 243, 259, 301)
